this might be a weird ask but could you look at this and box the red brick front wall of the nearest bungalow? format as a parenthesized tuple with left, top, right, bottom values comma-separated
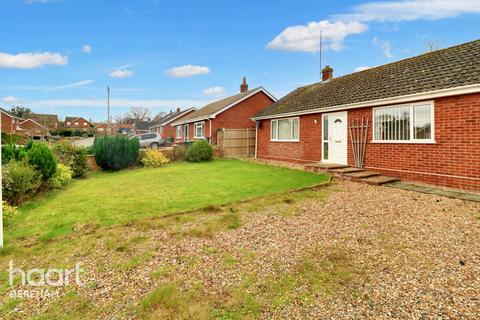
(257, 94, 480, 191)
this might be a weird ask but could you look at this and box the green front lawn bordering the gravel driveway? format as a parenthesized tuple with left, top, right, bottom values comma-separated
(6, 160, 328, 242)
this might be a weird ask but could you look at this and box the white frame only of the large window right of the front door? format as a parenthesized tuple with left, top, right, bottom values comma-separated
(371, 100, 436, 144)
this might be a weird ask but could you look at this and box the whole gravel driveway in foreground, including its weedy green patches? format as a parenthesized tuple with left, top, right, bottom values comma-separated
(2, 182, 480, 319)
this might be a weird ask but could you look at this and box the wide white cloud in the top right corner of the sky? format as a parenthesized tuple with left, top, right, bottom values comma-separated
(334, 0, 480, 22)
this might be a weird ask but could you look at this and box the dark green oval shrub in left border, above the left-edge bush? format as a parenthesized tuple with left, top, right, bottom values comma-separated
(26, 142, 57, 180)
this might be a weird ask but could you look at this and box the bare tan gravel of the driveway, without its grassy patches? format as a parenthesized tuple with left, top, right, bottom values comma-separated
(12, 181, 480, 319)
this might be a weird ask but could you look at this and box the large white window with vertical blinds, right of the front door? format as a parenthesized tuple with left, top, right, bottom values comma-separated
(373, 101, 435, 143)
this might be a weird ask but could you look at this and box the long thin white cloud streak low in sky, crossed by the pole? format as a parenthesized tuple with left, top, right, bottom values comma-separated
(28, 99, 208, 108)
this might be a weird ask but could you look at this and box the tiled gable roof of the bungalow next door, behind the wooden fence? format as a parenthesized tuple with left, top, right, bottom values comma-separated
(174, 87, 276, 124)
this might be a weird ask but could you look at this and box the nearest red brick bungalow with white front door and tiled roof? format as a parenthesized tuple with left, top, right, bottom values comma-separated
(253, 40, 480, 191)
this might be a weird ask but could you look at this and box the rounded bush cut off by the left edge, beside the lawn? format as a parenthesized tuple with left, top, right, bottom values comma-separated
(2, 160, 42, 204)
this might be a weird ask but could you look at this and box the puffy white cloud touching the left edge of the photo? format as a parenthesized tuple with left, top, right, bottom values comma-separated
(0, 52, 68, 69)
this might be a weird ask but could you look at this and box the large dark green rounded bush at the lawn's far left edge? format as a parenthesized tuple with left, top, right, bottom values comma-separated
(93, 135, 140, 170)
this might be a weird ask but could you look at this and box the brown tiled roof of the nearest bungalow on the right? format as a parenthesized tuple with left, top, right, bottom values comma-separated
(254, 40, 480, 118)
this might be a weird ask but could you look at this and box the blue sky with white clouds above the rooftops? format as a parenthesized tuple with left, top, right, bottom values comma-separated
(0, 0, 480, 121)
